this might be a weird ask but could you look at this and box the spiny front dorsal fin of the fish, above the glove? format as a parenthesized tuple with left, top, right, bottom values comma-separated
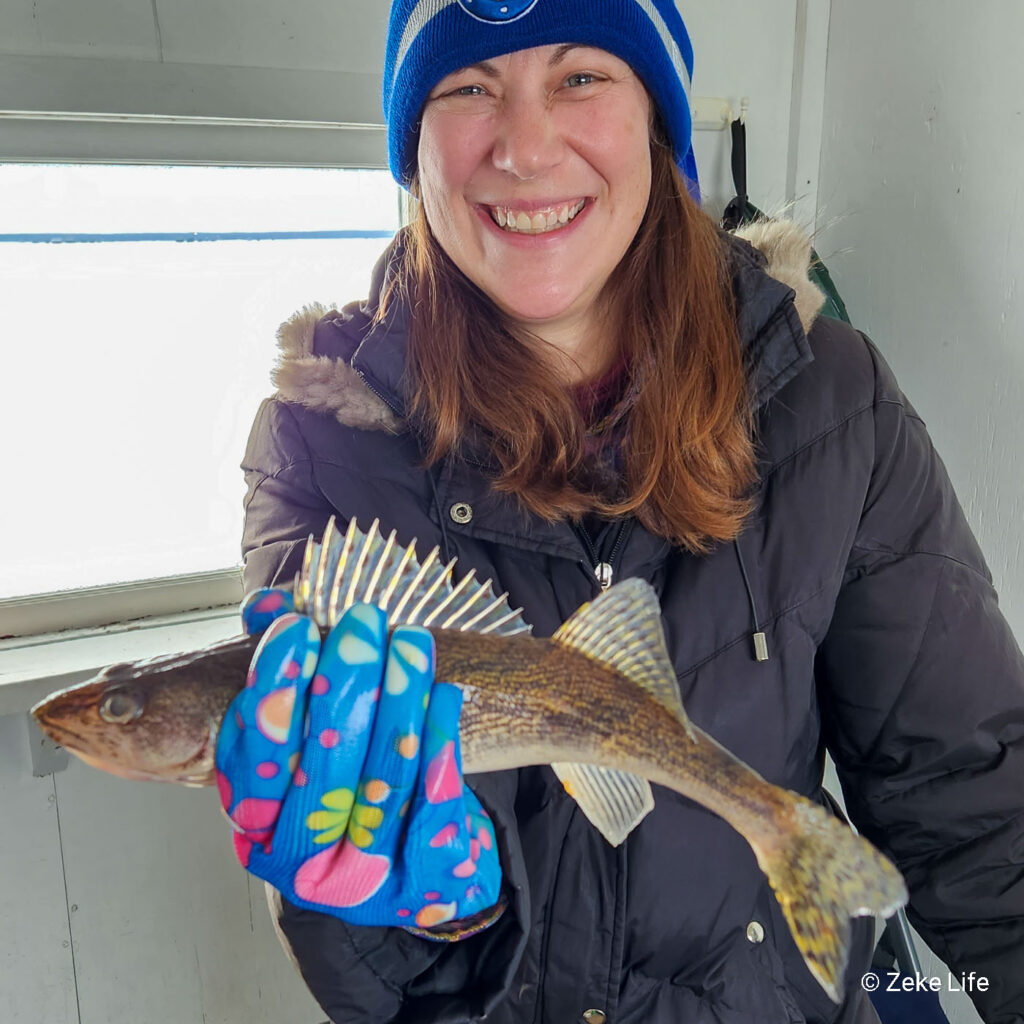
(293, 516, 532, 636)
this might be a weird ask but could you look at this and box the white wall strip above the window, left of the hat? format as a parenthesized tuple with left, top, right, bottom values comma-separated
(0, 0, 386, 167)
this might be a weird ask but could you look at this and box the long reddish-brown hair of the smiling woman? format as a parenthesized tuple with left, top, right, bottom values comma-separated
(382, 125, 755, 551)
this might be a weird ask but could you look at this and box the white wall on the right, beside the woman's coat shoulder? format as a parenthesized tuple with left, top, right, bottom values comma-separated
(818, 0, 1024, 639)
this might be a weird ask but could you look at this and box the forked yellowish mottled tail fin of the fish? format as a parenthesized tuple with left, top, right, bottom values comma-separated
(751, 795, 907, 1002)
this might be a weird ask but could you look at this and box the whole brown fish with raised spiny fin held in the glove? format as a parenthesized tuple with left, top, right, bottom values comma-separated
(32, 519, 907, 1004)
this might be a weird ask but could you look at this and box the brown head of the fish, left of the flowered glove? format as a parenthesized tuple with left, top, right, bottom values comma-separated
(32, 637, 254, 785)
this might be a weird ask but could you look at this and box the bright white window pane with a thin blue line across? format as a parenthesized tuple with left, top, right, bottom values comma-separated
(0, 164, 399, 610)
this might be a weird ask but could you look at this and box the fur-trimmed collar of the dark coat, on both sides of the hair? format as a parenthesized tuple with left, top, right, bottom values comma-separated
(272, 221, 824, 431)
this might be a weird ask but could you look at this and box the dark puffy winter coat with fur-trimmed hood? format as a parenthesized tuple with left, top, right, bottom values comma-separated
(244, 222, 1024, 1024)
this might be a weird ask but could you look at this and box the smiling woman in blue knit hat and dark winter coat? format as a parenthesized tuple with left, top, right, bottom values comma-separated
(221, 0, 1024, 1024)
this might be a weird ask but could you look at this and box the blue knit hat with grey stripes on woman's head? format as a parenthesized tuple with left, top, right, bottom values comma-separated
(384, 0, 698, 195)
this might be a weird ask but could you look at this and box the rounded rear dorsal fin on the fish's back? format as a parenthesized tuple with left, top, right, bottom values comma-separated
(551, 580, 689, 729)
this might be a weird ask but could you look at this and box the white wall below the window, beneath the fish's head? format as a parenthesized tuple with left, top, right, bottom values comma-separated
(0, 715, 324, 1024)
